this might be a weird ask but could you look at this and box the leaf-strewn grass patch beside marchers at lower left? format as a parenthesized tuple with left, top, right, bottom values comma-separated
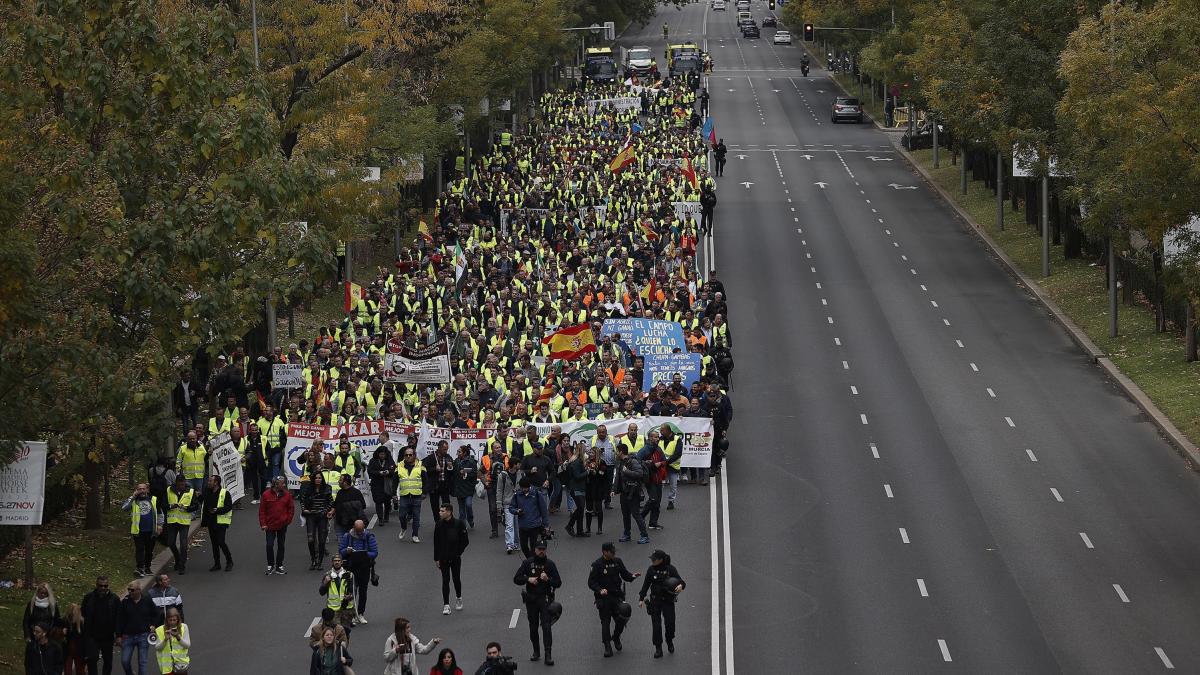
(0, 492, 133, 675)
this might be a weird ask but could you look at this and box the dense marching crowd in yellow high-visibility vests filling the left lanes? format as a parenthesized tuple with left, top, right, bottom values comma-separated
(25, 68, 733, 675)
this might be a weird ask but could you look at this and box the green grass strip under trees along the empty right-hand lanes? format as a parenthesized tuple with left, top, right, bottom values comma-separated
(912, 150, 1200, 443)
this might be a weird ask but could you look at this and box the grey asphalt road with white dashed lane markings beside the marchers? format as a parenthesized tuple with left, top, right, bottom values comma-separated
(164, 2, 1200, 675)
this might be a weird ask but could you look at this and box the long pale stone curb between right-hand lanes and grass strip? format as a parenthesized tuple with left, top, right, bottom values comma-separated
(893, 142, 1200, 471)
